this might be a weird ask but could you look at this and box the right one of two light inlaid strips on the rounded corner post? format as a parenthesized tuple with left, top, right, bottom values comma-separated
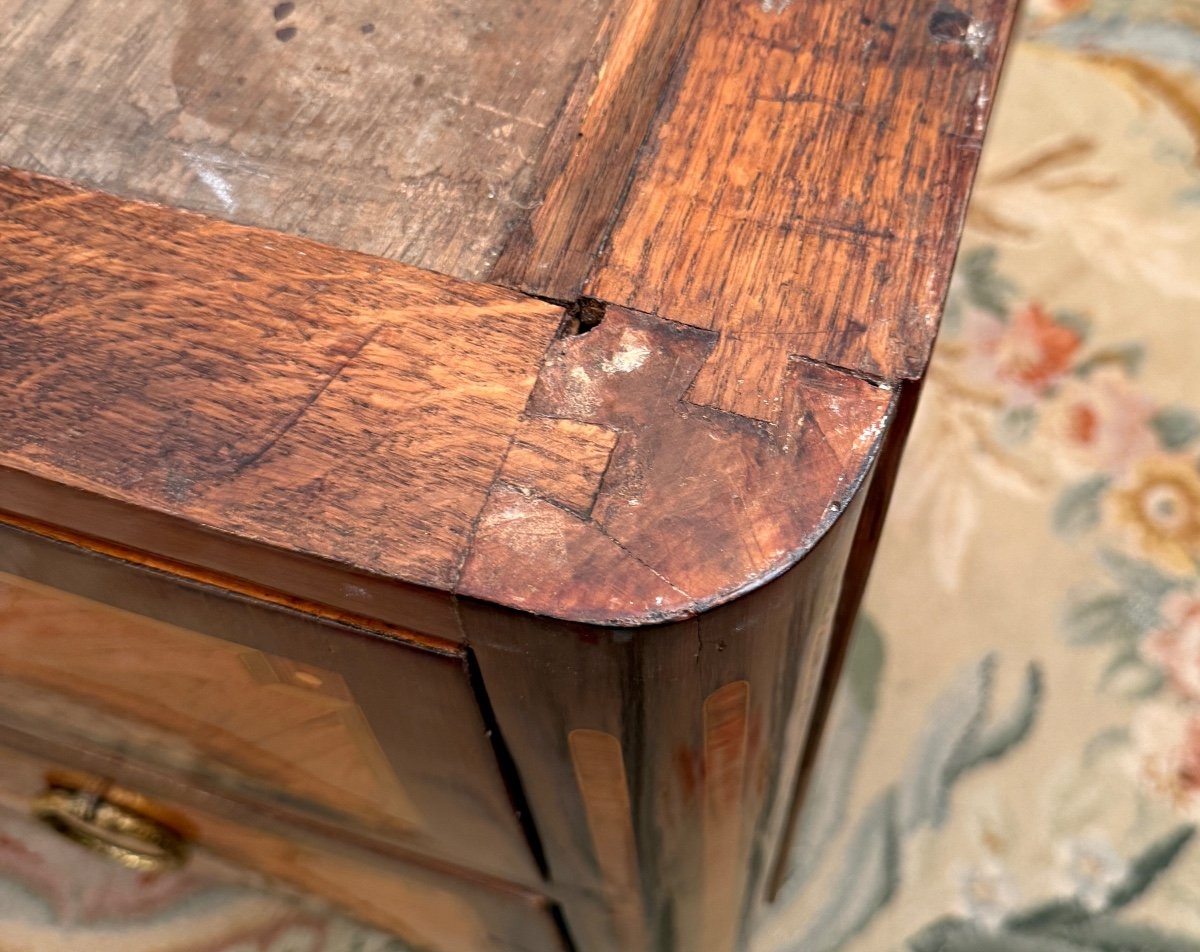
(702, 681, 750, 952)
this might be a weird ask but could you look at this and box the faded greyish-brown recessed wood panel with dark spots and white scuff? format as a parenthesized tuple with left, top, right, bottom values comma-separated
(0, 0, 610, 279)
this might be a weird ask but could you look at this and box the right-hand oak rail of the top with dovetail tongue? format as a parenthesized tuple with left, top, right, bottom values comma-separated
(587, 0, 1015, 421)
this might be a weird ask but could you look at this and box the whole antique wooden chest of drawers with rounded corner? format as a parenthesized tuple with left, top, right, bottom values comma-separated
(0, 0, 1012, 952)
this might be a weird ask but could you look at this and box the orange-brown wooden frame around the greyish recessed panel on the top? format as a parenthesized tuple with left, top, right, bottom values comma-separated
(0, 0, 1012, 639)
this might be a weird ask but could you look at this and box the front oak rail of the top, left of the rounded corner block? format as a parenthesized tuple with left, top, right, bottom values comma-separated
(0, 172, 562, 633)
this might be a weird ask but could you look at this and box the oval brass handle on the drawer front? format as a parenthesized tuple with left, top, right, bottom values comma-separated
(34, 786, 187, 873)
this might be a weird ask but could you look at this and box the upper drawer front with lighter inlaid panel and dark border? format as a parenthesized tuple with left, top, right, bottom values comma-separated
(0, 521, 539, 882)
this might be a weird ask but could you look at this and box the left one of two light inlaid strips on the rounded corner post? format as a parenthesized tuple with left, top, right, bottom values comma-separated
(568, 729, 648, 952)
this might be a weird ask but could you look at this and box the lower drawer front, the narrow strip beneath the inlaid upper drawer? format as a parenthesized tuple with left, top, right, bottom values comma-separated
(0, 734, 564, 952)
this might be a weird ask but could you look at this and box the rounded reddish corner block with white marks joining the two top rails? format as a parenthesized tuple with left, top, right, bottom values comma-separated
(456, 307, 895, 627)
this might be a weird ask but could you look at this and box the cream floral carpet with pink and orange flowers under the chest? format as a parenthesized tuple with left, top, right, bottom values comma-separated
(0, 0, 1200, 952)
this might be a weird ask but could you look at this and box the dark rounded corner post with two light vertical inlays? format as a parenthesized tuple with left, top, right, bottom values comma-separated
(462, 489, 858, 952)
